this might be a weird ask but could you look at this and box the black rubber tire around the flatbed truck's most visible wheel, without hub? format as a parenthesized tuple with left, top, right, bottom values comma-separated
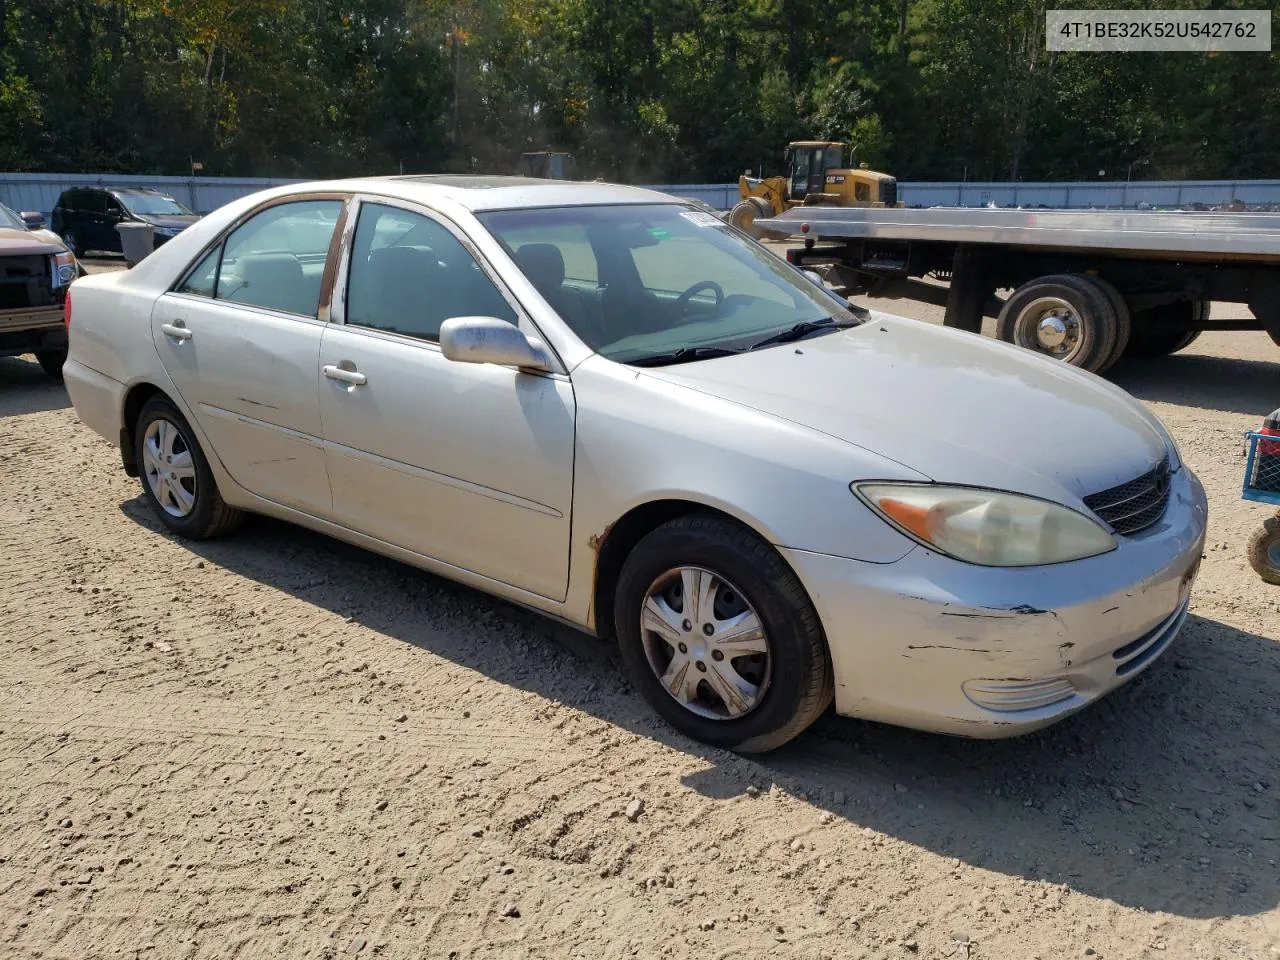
(996, 274, 1119, 372)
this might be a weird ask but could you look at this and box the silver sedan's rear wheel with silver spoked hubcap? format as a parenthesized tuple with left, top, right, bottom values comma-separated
(133, 397, 243, 540)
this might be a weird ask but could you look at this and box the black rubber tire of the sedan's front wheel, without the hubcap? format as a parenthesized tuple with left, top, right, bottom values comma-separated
(614, 513, 835, 753)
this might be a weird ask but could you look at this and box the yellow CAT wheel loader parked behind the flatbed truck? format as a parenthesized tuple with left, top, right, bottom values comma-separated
(728, 140, 905, 239)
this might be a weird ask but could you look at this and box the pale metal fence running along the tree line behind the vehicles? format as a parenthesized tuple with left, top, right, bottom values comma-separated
(0, 173, 1280, 216)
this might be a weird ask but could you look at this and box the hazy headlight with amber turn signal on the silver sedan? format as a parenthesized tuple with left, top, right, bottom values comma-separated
(852, 484, 1116, 567)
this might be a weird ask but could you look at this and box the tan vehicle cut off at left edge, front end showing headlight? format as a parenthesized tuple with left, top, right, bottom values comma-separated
(0, 204, 81, 376)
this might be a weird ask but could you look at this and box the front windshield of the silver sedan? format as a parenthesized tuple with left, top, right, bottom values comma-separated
(479, 204, 852, 364)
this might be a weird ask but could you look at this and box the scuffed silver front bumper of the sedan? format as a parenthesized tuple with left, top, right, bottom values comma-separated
(783, 466, 1208, 737)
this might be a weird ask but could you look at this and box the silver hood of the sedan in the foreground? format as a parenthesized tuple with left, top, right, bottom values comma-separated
(644, 314, 1169, 504)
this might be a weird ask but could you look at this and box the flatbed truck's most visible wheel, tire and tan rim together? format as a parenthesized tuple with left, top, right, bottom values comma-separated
(996, 274, 1119, 372)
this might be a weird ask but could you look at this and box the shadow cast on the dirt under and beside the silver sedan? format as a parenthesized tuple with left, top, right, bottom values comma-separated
(122, 497, 1280, 918)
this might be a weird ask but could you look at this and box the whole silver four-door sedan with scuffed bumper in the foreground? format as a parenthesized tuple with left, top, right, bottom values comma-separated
(65, 177, 1206, 751)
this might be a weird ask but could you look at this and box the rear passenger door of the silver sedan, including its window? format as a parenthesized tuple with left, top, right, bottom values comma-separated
(151, 195, 344, 517)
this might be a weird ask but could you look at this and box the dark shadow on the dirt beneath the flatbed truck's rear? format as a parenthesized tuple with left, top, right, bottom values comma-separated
(1107, 348, 1280, 419)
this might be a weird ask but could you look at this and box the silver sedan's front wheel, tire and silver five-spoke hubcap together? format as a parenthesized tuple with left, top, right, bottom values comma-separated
(614, 515, 833, 753)
